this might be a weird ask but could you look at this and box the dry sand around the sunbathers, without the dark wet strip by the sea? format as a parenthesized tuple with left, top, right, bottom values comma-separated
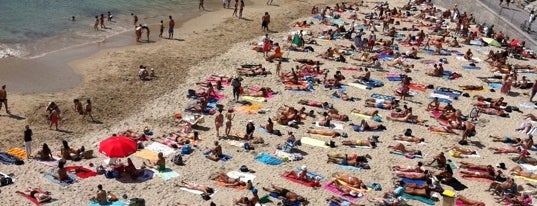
(0, 1, 531, 205)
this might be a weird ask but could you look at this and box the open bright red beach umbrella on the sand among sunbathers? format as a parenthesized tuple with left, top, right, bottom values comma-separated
(99, 136, 138, 158)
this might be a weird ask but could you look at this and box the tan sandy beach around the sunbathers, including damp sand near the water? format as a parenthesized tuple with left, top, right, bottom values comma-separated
(0, 0, 536, 205)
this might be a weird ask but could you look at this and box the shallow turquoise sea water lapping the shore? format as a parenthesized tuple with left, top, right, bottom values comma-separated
(0, 0, 198, 58)
